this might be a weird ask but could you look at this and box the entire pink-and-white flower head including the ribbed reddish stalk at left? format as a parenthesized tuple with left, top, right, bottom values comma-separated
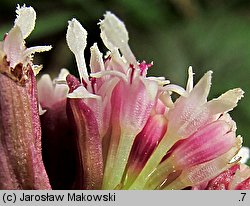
(0, 6, 244, 189)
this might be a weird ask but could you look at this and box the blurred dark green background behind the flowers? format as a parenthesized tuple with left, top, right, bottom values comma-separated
(0, 0, 250, 163)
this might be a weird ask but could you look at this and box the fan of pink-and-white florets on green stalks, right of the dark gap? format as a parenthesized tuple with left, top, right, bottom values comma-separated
(37, 12, 248, 189)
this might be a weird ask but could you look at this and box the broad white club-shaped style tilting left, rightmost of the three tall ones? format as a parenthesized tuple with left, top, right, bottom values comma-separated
(99, 12, 138, 67)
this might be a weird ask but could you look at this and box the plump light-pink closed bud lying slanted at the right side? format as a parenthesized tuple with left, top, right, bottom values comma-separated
(172, 121, 235, 168)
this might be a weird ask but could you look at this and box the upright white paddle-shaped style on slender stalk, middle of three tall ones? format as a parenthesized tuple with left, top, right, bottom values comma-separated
(66, 19, 89, 82)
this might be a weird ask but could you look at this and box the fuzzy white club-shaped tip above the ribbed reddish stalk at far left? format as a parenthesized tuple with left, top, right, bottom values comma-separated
(15, 4, 36, 39)
